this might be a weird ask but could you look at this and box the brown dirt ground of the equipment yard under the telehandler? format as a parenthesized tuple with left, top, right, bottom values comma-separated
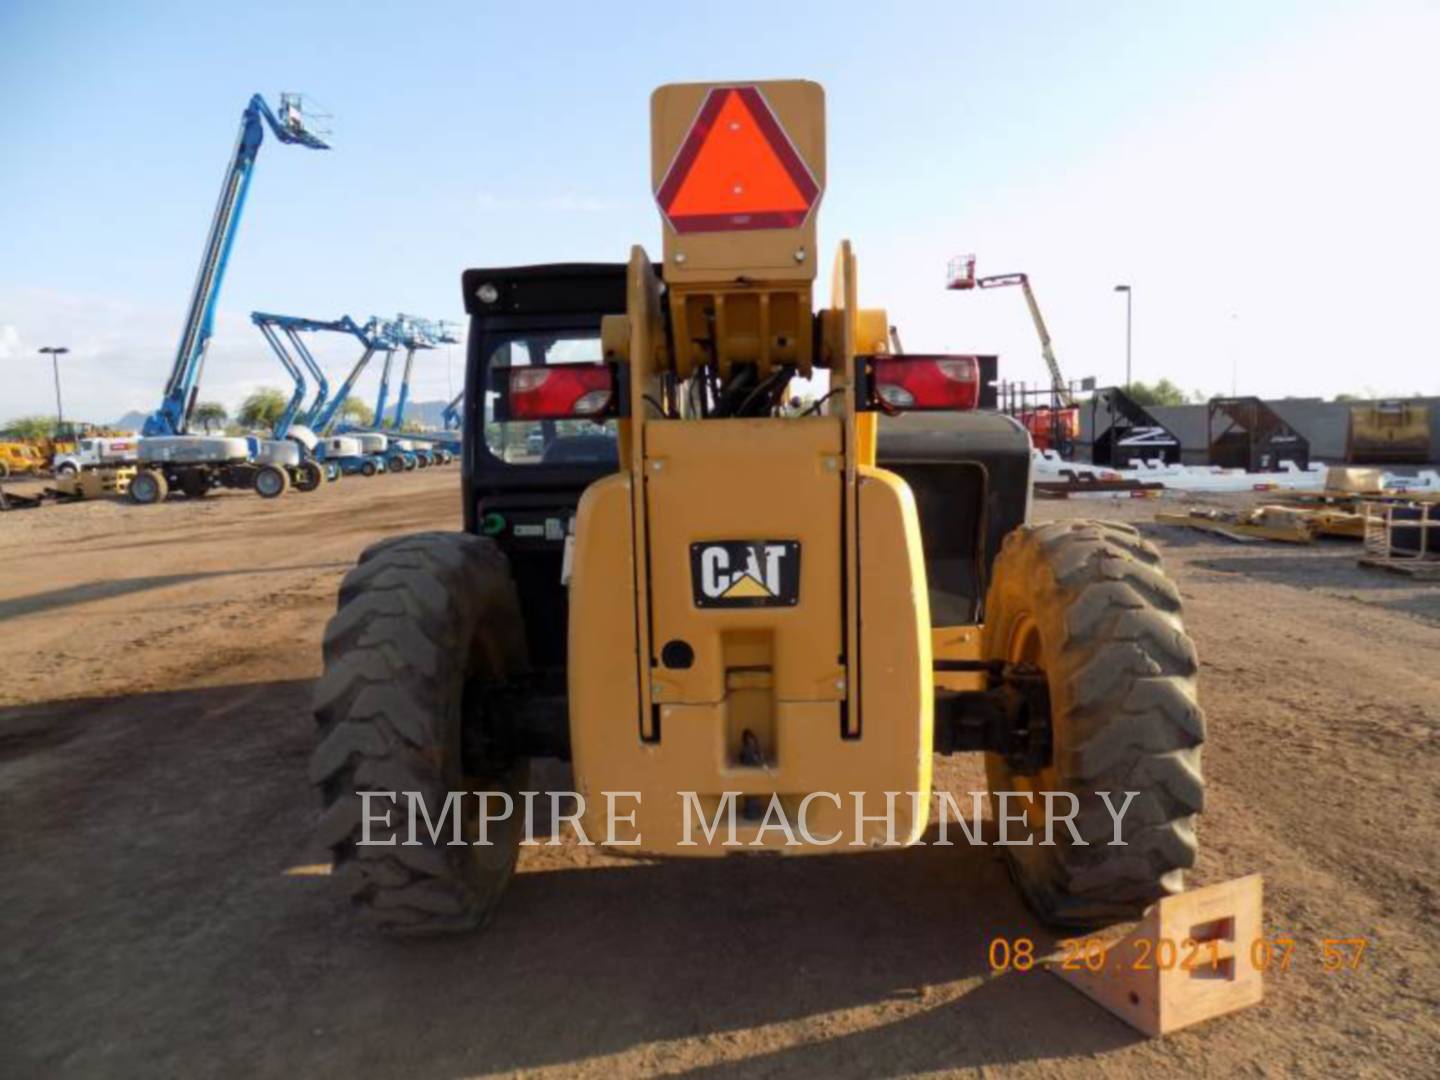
(0, 468, 1440, 1077)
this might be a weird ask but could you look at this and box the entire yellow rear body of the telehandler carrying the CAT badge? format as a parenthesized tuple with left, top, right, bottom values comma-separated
(569, 434, 933, 855)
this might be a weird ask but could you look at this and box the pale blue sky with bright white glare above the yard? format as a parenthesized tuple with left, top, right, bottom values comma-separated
(0, 0, 1440, 420)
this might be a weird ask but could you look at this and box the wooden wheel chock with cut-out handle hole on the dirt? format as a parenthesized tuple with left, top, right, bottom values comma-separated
(1048, 874, 1264, 1035)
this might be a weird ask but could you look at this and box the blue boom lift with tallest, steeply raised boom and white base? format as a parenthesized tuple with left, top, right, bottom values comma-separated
(130, 94, 330, 503)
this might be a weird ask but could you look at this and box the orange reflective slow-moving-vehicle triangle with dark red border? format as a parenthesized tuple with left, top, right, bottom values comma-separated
(655, 86, 819, 233)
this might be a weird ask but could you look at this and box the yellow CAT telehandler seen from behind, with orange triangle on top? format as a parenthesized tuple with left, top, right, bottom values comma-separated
(311, 81, 1204, 933)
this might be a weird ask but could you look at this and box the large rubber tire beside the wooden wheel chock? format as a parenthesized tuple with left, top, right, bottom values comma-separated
(982, 521, 1205, 927)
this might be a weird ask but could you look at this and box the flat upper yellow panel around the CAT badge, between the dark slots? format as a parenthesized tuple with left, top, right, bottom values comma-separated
(645, 416, 845, 711)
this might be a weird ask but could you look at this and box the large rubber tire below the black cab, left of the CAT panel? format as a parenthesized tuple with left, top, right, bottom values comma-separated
(310, 533, 528, 935)
